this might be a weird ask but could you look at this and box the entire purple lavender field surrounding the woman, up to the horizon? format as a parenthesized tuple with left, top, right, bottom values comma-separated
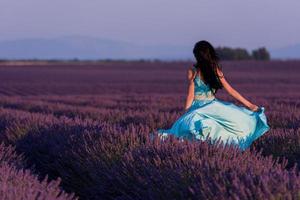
(0, 61, 300, 200)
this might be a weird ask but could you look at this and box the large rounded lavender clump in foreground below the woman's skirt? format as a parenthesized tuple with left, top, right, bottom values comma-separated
(110, 136, 300, 200)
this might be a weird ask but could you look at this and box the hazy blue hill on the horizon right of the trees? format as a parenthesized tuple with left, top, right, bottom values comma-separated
(270, 44, 300, 59)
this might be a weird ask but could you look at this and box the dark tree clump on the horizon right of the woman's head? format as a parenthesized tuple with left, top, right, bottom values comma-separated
(216, 47, 271, 60)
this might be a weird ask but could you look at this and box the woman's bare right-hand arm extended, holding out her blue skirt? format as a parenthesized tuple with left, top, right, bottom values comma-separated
(217, 68, 258, 111)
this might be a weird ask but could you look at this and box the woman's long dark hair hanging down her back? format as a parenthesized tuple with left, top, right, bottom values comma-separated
(193, 40, 223, 93)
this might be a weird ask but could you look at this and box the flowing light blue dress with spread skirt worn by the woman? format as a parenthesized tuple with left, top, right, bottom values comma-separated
(157, 68, 270, 150)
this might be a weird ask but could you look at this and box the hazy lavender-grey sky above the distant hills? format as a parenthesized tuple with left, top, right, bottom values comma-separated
(0, 0, 300, 49)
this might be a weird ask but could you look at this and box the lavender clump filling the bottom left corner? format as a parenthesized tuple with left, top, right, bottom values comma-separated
(0, 143, 77, 200)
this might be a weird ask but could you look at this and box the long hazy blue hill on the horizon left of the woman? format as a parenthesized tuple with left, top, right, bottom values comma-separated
(0, 36, 192, 60)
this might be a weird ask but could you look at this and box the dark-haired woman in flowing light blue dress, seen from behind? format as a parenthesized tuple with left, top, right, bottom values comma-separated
(158, 40, 269, 150)
